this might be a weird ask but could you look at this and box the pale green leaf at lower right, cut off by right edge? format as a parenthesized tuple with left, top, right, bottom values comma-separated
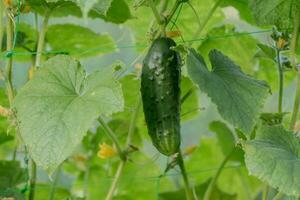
(244, 125, 300, 196)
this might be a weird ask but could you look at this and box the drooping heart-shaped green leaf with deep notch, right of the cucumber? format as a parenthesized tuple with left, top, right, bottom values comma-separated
(187, 49, 269, 133)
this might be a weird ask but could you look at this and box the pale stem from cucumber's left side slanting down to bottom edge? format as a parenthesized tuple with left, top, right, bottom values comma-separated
(105, 97, 142, 200)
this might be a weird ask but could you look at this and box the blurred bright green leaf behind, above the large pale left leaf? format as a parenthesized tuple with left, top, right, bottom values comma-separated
(46, 24, 115, 57)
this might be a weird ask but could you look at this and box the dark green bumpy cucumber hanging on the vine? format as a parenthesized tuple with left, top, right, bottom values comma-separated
(141, 37, 181, 156)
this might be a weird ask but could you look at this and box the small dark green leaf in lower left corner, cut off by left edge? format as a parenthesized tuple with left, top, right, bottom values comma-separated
(0, 160, 26, 190)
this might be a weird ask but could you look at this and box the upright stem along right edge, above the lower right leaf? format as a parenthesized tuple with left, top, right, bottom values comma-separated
(290, 10, 300, 130)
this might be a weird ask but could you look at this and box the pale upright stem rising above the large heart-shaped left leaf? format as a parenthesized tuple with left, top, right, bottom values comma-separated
(35, 10, 51, 67)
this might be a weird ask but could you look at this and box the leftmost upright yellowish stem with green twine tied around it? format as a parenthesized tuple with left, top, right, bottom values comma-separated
(6, 11, 14, 107)
